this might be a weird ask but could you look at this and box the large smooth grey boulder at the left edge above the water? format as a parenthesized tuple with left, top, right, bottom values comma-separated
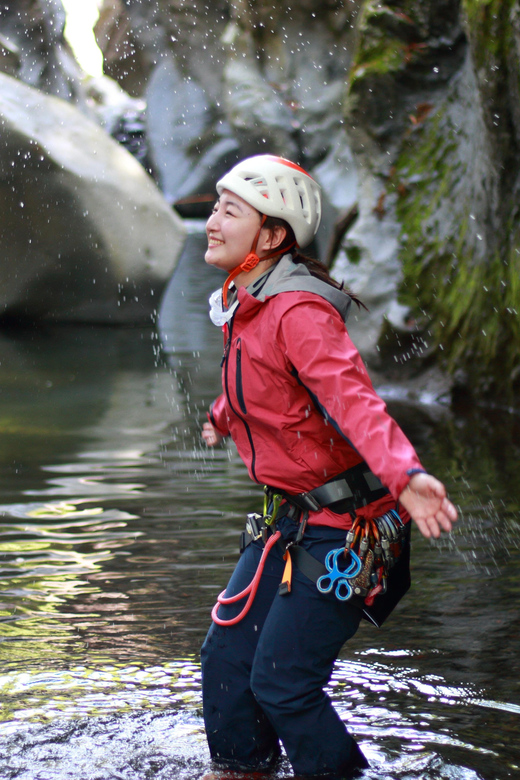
(0, 68, 185, 323)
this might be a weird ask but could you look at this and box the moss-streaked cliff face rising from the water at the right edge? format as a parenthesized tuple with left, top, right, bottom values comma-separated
(350, 0, 520, 391)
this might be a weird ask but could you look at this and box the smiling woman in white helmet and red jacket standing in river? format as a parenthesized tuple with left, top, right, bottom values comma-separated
(202, 155, 457, 778)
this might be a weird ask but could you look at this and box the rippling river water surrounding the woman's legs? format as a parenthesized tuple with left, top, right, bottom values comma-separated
(0, 226, 520, 780)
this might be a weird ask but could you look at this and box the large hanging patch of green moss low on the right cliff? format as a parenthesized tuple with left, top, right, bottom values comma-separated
(394, 112, 520, 390)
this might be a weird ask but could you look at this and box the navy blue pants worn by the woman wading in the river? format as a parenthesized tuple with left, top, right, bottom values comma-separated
(202, 526, 368, 780)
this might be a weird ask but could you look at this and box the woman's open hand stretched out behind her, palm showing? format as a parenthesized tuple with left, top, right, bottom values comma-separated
(399, 474, 457, 539)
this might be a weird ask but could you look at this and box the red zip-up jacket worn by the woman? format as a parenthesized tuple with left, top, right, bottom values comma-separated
(210, 266, 424, 528)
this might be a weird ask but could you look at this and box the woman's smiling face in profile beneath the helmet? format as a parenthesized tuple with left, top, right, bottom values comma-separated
(204, 190, 261, 273)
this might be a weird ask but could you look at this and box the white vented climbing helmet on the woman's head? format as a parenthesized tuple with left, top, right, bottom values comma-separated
(217, 154, 321, 247)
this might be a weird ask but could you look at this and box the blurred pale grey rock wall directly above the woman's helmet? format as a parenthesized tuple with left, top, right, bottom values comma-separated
(97, 0, 359, 206)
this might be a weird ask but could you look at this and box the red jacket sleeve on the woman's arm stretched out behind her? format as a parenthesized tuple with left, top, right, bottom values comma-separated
(279, 296, 424, 500)
